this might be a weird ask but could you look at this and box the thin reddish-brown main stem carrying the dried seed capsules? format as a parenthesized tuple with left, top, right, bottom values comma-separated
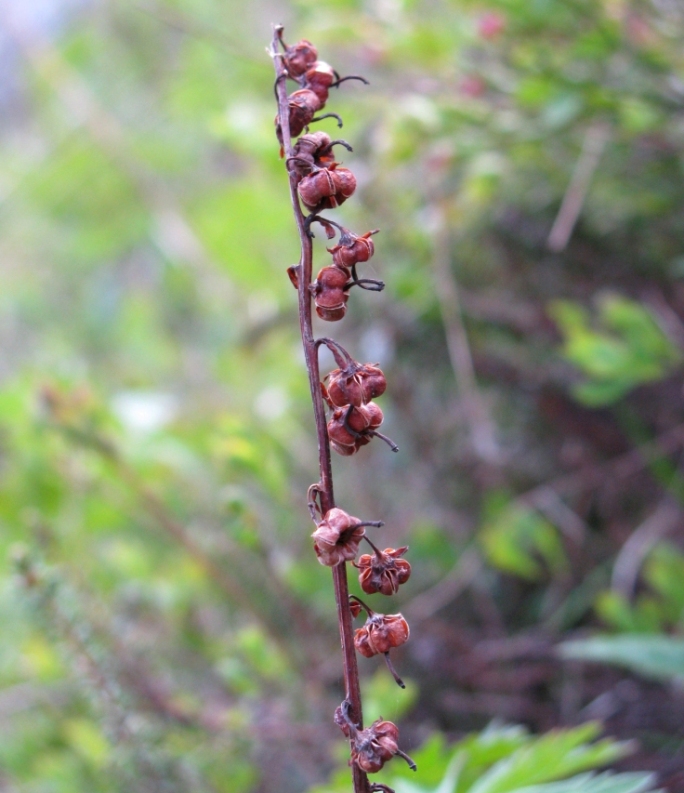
(271, 25, 370, 793)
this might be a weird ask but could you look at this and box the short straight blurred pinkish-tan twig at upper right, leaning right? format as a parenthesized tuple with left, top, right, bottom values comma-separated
(546, 123, 610, 253)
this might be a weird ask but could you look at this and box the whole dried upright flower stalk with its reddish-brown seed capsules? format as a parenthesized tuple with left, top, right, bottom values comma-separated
(270, 25, 415, 793)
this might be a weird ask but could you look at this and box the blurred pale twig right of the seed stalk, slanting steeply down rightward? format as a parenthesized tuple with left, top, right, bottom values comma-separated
(432, 208, 501, 465)
